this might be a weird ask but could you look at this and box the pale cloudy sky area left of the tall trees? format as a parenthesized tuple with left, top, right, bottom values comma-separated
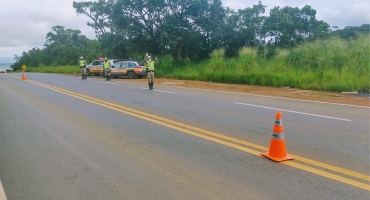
(0, 0, 95, 57)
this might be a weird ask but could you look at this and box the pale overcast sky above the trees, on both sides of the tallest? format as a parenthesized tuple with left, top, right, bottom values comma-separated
(0, 0, 370, 57)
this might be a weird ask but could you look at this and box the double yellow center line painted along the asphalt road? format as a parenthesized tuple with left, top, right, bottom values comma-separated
(17, 76, 370, 191)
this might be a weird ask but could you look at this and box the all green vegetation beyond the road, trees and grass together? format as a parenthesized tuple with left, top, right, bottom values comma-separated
(11, 0, 370, 92)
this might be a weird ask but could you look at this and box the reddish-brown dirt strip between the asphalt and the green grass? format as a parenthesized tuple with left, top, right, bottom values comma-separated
(76, 74, 370, 107)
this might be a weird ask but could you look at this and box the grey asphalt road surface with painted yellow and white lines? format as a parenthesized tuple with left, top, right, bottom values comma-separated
(0, 73, 370, 200)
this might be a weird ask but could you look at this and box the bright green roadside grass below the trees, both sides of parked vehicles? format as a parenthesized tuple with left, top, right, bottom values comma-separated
(16, 34, 370, 93)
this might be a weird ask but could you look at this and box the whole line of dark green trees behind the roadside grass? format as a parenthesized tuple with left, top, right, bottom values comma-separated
(12, 0, 369, 70)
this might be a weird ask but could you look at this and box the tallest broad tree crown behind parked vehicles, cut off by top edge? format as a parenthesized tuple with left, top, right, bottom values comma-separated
(73, 0, 224, 59)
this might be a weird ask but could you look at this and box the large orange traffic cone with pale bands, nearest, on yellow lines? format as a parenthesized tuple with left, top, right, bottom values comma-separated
(262, 112, 294, 162)
